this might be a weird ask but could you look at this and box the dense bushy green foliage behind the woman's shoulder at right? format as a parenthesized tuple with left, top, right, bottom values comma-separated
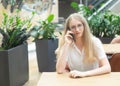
(88, 10, 120, 37)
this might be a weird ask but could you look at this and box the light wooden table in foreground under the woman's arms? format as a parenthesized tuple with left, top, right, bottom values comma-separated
(37, 72, 120, 86)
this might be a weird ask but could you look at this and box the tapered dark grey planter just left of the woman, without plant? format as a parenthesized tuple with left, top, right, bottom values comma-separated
(36, 39, 58, 72)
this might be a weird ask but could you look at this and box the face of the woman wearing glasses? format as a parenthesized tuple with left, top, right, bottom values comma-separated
(69, 19, 84, 39)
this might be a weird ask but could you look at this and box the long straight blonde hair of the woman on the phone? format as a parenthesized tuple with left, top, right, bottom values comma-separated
(56, 13, 97, 63)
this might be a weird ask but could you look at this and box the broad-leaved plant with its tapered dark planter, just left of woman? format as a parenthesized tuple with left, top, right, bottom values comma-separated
(31, 14, 58, 72)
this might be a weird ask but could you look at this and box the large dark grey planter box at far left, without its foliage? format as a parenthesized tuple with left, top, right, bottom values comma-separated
(0, 44, 29, 86)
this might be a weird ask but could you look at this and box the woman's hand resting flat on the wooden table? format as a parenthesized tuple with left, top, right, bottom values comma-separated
(70, 70, 86, 78)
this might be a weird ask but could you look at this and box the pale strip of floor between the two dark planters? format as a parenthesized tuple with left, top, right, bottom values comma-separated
(23, 43, 41, 86)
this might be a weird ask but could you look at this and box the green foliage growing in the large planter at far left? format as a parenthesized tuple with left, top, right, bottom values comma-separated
(0, 12, 31, 50)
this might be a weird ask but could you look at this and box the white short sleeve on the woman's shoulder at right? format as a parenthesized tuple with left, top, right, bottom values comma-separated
(94, 37, 107, 59)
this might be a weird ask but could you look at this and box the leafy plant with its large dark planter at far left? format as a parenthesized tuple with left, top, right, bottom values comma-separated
(0, 10, 31, 86)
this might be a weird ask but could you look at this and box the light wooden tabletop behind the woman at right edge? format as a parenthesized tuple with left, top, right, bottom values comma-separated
(103, 44, 120, 54)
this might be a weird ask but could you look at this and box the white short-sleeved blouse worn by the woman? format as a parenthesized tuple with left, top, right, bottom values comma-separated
(66, 37, 107, 71)
